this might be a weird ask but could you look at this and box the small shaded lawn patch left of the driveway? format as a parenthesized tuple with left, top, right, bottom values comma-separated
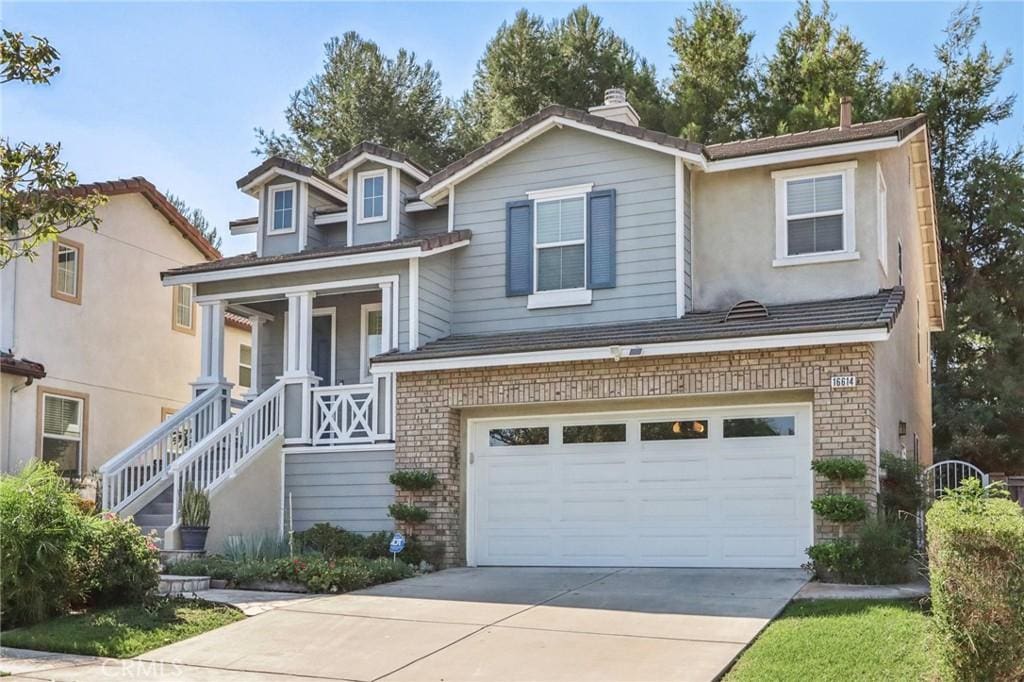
(0, 599, 245, 658)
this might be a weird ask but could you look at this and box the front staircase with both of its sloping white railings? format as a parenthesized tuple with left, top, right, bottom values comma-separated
(100, 382, 285, 549)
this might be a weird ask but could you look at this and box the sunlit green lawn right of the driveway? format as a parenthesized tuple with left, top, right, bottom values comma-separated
(725, 599, 935, 682)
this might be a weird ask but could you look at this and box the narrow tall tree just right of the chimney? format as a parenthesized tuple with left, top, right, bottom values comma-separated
(669, 0, 754, 143)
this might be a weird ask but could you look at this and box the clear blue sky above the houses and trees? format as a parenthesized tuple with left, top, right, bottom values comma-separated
(6, 2, 1024, 254)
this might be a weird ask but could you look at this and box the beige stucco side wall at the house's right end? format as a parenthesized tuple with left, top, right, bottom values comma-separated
(871, 144, 933, 464)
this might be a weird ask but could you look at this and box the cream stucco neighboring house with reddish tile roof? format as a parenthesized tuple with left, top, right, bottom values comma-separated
(0, 177, 251, 489)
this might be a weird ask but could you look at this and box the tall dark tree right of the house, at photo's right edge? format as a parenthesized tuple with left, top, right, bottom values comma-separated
(890, 6, 1024, 472)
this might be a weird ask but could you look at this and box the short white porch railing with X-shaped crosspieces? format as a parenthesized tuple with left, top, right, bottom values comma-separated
(310, 375, 391, 445)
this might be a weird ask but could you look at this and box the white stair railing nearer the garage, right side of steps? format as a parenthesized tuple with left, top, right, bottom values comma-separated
(171, 381, 285, 522)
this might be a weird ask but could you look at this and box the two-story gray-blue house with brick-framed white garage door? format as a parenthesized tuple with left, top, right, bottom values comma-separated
(108, 90, 943, 567)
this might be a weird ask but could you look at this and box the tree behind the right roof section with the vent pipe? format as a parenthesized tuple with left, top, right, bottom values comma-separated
(754, 0, 886, 135)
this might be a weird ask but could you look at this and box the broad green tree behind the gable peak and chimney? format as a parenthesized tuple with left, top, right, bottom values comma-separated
(456, 5, 665, 153)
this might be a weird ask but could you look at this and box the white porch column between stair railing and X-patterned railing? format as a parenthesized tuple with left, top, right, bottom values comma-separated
(282, 291, 319, 443)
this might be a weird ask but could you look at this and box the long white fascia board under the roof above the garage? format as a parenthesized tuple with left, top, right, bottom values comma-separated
(371, 328, 890, 374)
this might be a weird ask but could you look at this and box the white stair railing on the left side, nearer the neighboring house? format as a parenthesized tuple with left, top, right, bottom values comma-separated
(99, 389, 226, 512)
